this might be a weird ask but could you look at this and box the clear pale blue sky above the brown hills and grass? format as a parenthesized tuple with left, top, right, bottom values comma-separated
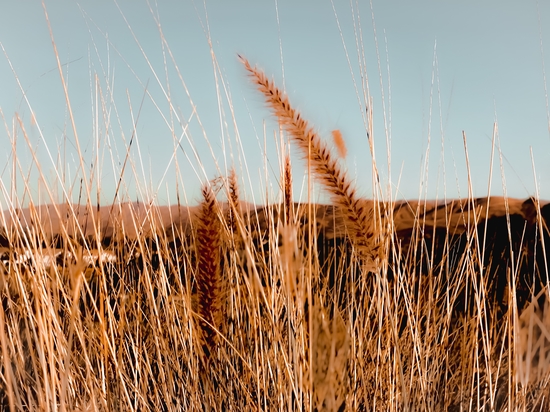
(0, 0, 550, 208)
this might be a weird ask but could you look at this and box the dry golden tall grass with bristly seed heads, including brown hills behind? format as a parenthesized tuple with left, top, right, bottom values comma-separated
(0, 4, 550, 411)
